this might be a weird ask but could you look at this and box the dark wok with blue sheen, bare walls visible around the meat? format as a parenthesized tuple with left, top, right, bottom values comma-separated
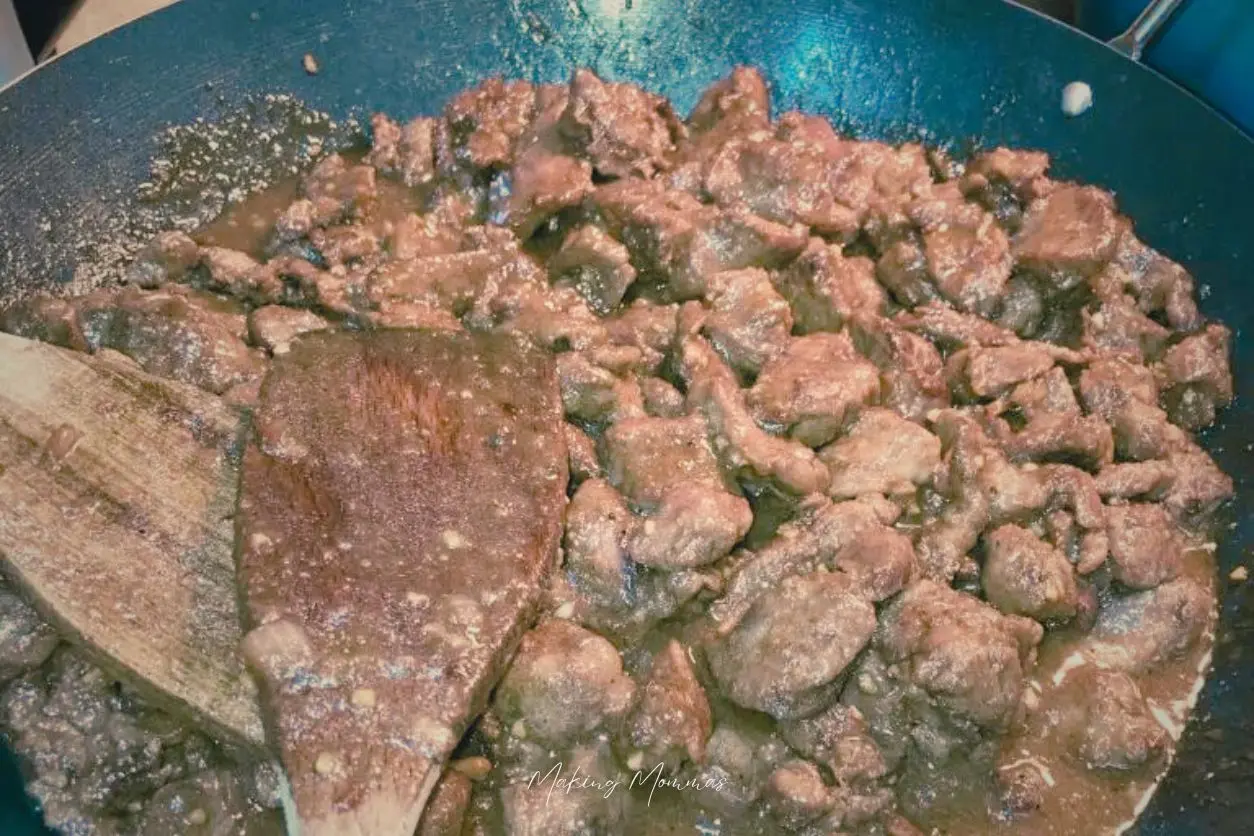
(0, 0, 1254, 835)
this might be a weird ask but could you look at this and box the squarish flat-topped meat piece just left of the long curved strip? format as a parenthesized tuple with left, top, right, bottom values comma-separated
(604, 416, 722, 508)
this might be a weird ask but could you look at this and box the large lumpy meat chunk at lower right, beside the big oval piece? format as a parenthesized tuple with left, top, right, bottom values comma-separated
(877, 580, 1042, 729)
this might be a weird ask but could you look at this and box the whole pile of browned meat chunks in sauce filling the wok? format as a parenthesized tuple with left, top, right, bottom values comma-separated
(0, 68, 1233, 836)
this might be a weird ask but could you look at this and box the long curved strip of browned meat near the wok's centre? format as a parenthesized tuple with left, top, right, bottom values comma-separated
(681, 337, 830, 496)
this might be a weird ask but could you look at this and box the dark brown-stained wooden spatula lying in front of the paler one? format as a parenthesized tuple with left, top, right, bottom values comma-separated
(237, 331, 567, 836)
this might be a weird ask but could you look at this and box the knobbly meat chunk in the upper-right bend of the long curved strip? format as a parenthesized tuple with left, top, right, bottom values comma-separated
(747, 333, 879, 447)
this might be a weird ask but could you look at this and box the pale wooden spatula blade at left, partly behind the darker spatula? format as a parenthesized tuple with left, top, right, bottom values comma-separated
(0, 333, 265, 751)
